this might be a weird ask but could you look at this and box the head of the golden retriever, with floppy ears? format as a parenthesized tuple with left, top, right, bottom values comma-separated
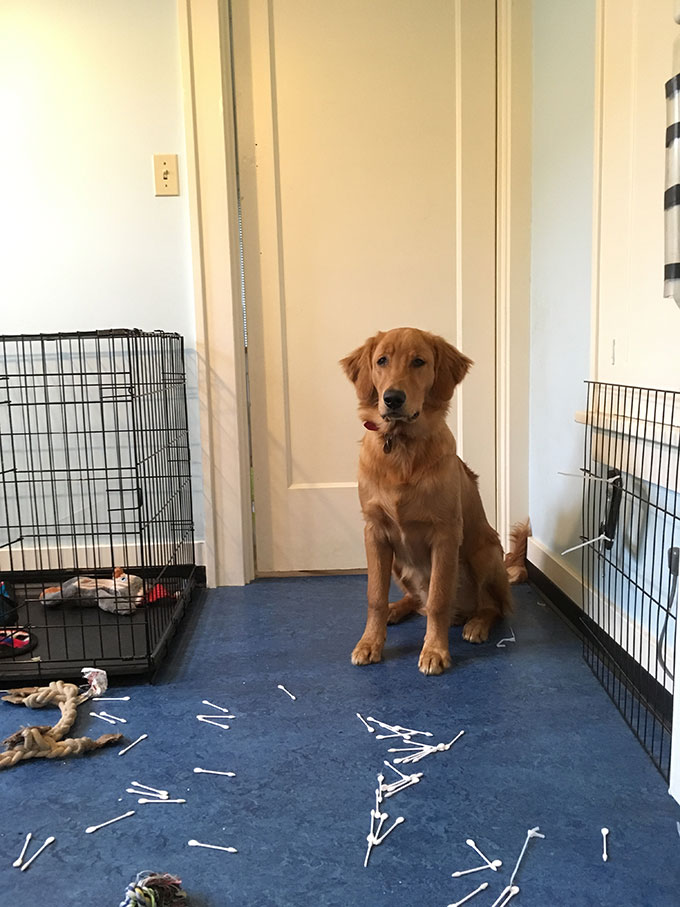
(340, 328, 472, 423)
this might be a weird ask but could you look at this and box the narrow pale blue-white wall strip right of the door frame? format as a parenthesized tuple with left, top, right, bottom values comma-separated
(529, 0, 595, 602)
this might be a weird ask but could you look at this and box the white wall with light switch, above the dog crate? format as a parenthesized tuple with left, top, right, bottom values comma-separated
(0, 0, 203, 538)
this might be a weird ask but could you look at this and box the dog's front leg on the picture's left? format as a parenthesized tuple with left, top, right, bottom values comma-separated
(352, 523, 393, 664)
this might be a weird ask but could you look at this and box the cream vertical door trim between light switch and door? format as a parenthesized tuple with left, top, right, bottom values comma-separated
(178, 0, 254, 586)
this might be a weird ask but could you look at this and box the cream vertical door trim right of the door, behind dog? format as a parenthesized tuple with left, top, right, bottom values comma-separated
(496, 0, 532, 547)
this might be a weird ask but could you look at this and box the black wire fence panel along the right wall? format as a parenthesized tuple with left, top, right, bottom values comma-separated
(583, 382, 680, 780)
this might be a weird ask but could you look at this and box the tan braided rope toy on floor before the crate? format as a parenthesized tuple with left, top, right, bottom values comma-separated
(0, 680, 123, 770)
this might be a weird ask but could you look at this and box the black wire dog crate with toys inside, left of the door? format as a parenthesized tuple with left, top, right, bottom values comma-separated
(0, 330, 197, 683)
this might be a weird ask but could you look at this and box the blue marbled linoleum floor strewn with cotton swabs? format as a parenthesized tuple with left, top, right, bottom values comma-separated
(0, 576, 680, 907)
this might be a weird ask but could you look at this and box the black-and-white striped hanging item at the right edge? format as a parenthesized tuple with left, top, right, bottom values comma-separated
(663, 73, 680, 306)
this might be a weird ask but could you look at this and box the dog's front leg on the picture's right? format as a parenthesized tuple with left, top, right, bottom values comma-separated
(418, 533, 461, 674)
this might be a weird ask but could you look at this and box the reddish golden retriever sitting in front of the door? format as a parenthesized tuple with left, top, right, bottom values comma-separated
(340, 328, 511, 674)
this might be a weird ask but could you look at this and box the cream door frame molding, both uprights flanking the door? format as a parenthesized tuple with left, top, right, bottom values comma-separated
(177, 0, 531, 586)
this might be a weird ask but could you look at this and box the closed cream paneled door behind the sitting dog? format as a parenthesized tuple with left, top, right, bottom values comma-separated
(232, 0, 496, 573)
